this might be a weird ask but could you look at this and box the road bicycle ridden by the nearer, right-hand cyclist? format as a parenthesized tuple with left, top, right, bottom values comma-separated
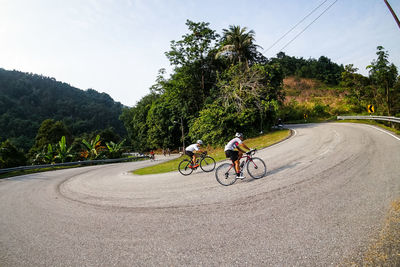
(215, 149, 267, 186)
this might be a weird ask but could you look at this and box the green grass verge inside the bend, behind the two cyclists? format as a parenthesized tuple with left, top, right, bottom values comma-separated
(133, 129, 290, 175)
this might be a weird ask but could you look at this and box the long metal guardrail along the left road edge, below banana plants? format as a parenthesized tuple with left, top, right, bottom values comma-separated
(0, 156, 148, 174)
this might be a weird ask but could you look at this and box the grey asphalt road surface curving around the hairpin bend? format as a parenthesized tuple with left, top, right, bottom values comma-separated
(0, 123, 400, 266)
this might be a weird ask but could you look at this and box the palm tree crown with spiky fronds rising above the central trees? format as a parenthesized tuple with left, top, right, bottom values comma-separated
(216, 25, 260, 69)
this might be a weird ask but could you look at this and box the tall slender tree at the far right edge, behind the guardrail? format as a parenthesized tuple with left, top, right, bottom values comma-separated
(367, 46, 398, 116)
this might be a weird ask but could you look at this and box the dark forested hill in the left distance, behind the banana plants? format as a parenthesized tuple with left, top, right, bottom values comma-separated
(0, 68, 125, 152)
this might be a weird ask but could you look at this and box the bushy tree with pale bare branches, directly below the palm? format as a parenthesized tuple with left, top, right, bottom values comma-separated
(189, 63, 283, 144)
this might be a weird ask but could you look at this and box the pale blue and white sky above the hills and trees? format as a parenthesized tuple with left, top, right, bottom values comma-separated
(0, 0, 400, 107)
